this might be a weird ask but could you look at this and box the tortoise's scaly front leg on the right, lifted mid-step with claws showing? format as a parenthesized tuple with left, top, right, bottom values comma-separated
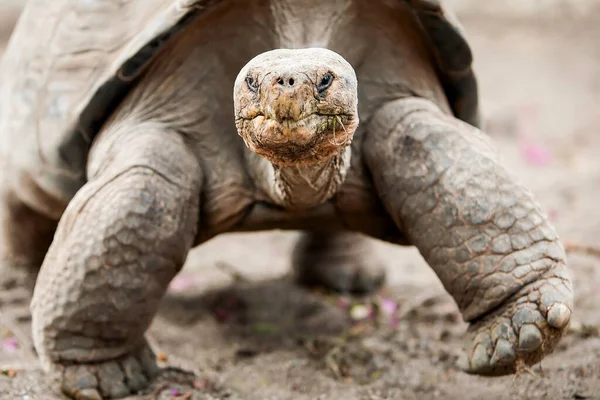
(364, 99, 573, 375)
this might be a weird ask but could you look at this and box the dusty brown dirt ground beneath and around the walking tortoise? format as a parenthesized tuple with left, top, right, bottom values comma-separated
(0, 0, 600, 400)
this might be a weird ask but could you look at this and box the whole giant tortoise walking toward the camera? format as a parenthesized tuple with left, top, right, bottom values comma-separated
(0, 0, 573, 399)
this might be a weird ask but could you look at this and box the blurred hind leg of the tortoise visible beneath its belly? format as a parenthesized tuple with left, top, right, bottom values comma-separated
(292, 232, 385, 294)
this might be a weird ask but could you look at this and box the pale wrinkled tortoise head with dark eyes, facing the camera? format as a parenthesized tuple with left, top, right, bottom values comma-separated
(234, 48, 359, 166)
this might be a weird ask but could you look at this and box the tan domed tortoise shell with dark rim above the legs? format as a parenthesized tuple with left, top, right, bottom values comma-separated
(0, 0, 479, 209)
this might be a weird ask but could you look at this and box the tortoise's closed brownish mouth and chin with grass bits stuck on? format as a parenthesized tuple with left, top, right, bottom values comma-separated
(236, 113, 358, 166)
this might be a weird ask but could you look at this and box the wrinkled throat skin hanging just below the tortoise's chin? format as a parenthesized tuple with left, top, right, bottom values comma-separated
(248, 146, 351, 210)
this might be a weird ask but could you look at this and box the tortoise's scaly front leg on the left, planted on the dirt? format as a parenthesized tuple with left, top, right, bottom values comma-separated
(32, 126, 202, 399)
